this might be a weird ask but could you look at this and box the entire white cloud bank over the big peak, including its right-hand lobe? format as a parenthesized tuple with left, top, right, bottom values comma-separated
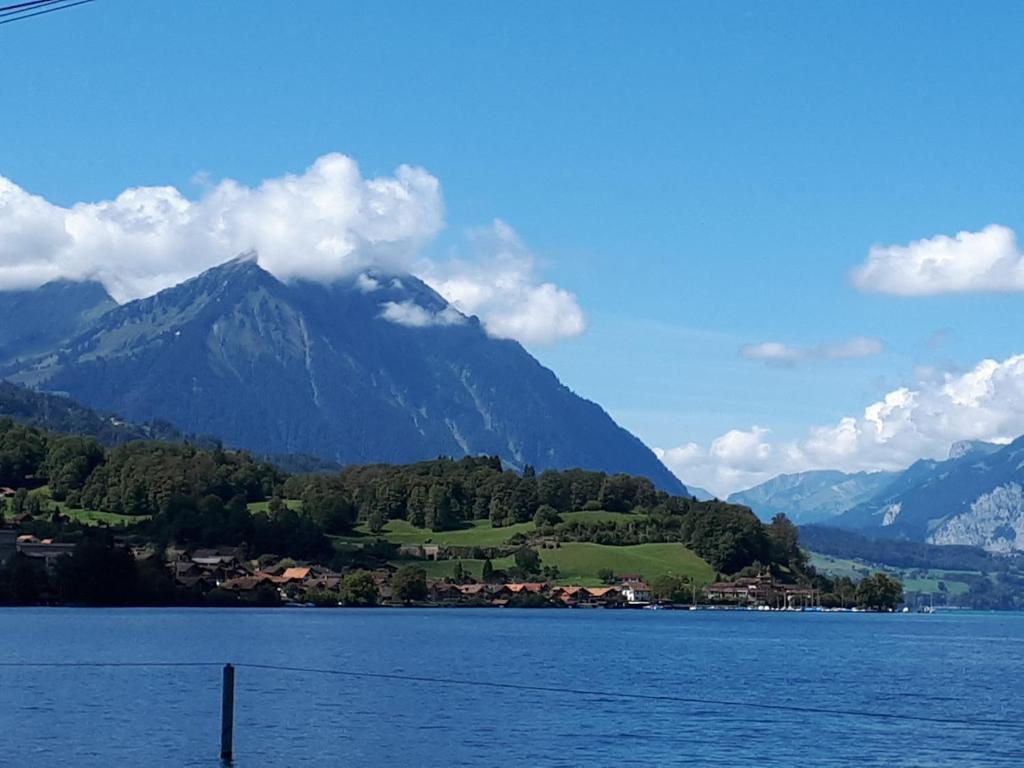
(0, 154, 586, 343)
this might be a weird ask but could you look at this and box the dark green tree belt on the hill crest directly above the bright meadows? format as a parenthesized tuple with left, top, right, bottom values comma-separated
(284, 457, 808, 574)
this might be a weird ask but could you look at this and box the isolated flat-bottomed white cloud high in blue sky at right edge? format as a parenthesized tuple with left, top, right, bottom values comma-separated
(852, 224, 1024, 296)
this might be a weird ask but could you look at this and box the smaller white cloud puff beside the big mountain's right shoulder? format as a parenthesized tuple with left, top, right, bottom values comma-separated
(421, 220, 587, 344)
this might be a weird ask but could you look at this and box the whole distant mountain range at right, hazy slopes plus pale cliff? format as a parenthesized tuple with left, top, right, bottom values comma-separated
(728, 437, 1024, 553)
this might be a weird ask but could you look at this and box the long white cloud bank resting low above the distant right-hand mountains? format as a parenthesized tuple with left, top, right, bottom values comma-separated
(656, 354, 1024, 497)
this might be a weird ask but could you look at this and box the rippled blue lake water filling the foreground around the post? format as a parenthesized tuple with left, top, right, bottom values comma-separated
(0, 608, 1024, 768)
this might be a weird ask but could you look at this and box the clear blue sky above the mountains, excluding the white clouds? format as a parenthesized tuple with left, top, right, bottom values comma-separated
(0, 0, 1024, 492)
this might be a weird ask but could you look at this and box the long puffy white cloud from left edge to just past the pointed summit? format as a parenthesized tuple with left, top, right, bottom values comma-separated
(0, 154, 443, 301)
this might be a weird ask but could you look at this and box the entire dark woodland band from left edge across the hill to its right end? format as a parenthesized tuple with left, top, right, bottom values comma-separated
(6, 420, 806, 573)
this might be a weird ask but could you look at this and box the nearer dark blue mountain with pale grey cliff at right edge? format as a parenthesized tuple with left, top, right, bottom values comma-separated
(830, 437, 1024, 553)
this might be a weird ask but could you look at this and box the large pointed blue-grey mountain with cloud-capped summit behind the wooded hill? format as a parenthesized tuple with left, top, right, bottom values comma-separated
(0, 259, 685, 494)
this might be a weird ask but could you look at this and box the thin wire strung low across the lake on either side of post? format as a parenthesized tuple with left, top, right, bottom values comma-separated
(0, 662, 1024, 731)
